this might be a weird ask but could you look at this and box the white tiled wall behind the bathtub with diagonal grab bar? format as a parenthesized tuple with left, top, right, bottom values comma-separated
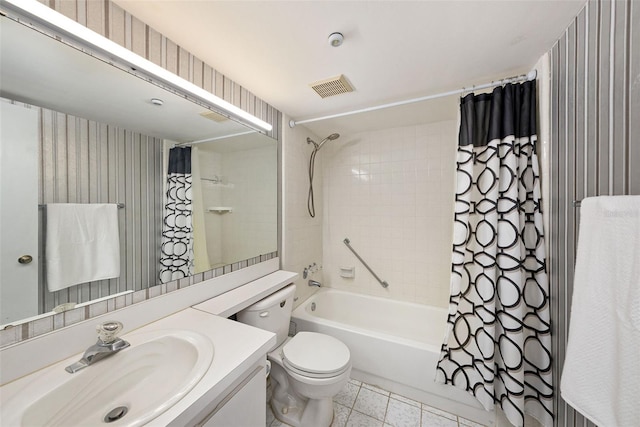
(322, 121, 457, 307)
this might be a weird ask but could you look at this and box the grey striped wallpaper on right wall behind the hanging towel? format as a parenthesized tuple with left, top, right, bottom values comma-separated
(550, 0, 640, 427)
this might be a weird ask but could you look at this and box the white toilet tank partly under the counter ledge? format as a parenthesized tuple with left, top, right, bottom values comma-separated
(236, 284, 296, 348)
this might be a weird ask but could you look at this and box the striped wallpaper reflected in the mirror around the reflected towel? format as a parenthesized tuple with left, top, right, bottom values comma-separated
(34, 107, 164, 312)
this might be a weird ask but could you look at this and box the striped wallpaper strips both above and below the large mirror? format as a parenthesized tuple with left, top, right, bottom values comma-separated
(0, 0, 283, 348)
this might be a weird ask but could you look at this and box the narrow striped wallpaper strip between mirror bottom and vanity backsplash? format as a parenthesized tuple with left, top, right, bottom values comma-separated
(0, 251, 278, 348)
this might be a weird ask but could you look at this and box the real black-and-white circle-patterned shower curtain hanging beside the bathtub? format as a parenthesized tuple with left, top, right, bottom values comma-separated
(436, 81, 553, 426)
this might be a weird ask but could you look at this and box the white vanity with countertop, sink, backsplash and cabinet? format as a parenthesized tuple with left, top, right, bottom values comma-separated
(0, 271, 297, 427)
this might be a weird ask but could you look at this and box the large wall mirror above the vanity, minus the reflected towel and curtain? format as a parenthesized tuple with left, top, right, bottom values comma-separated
(0, 16, 277, 325)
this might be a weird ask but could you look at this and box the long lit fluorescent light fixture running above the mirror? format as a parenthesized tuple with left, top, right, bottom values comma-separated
(0, 0, 273, 132)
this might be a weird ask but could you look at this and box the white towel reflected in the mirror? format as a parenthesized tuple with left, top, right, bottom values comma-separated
(45, 203, 120, 292)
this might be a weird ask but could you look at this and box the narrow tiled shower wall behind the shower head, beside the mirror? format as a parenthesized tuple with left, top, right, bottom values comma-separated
(280, 117, 324, 307)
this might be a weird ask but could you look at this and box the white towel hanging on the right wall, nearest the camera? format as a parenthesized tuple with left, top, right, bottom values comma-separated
(560, 196, 640, 427)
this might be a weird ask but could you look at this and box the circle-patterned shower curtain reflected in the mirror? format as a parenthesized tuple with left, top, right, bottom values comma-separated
(160, 147, 193, 283)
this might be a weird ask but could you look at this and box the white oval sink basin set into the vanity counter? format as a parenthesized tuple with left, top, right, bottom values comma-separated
(0, 329, 214, 427)
